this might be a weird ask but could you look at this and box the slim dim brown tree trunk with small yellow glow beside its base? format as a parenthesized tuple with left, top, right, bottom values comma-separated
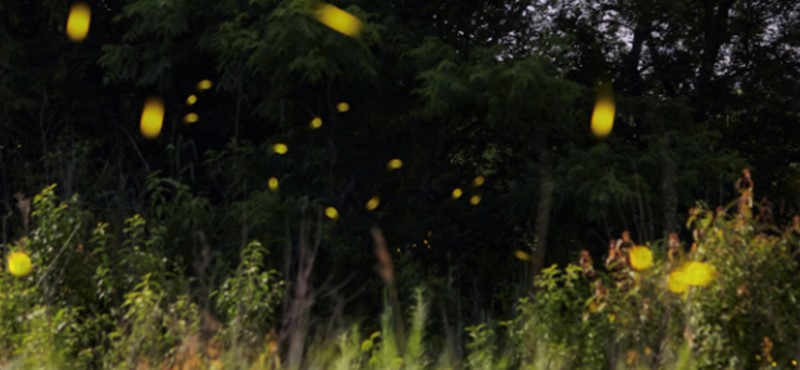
(531, 149, 555, 277)
